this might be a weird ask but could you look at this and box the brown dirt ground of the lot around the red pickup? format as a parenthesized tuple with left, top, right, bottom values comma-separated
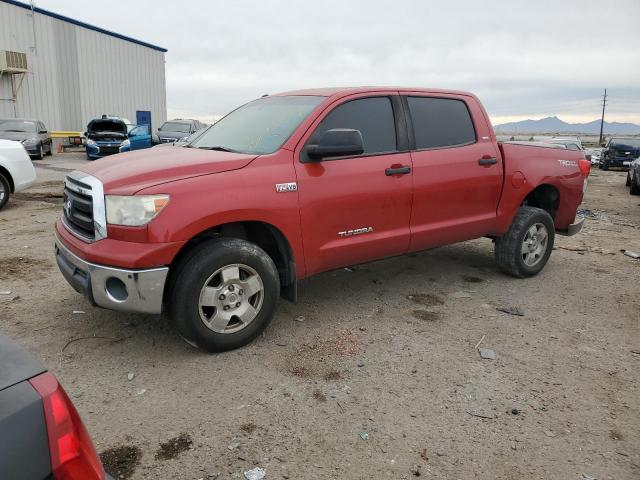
(0, 155, 640, 480)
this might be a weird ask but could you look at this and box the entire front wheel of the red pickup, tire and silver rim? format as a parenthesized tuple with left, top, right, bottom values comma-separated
(169, 238, 280, 352)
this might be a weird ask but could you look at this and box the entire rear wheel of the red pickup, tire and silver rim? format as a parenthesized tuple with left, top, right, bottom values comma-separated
(495, 207, 555, 278)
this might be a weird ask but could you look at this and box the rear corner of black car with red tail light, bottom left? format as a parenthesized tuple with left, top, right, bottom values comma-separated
(0, 333, 113, 480)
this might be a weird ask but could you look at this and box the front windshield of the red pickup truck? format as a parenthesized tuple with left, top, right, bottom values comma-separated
(191, 96, 325, 155)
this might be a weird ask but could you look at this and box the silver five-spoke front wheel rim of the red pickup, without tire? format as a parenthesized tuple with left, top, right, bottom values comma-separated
(198, 263, 264, 334)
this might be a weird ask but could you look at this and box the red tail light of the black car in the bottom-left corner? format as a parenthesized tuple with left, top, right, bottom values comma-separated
(29, 373, 105, 480)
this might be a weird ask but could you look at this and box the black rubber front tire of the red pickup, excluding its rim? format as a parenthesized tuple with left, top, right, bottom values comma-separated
(167, 238, 280, 352)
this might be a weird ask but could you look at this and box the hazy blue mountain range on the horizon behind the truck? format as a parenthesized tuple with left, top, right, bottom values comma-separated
(493, 117, 640, 135)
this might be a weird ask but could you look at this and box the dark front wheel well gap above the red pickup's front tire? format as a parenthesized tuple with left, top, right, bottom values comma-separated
(169, 221, 297, 301)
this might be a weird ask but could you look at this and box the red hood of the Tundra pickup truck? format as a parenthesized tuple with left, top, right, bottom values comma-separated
(80, 147, 256, 195)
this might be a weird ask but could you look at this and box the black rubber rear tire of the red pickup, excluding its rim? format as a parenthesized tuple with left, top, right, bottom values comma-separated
(495, 207, 555, 278)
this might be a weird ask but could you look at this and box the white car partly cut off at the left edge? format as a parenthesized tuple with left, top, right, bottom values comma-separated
(0, 140, 36, 210)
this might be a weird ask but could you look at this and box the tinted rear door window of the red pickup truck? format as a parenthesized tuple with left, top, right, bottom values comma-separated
(407, 97, 476, 150)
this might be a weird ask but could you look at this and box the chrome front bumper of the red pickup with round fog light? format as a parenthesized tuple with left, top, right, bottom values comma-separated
(54, 235, 169, 313)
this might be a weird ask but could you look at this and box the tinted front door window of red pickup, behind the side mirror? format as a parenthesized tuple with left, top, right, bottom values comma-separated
(308, 97, 397, 155)
